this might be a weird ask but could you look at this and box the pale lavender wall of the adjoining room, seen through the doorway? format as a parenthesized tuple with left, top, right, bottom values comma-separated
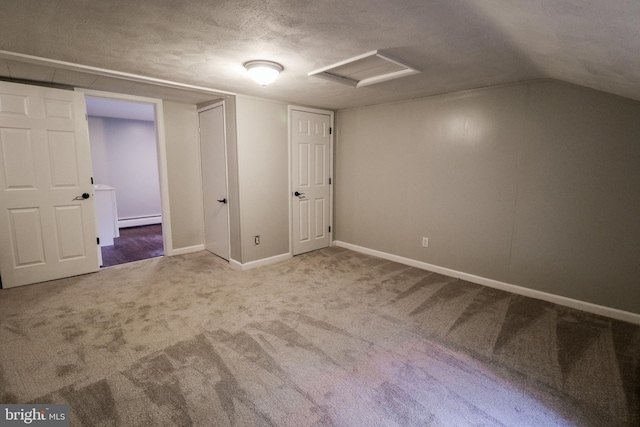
(89, 116, 162, 220)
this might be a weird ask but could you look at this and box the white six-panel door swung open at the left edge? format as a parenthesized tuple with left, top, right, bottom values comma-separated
(0, 82, 99, 288)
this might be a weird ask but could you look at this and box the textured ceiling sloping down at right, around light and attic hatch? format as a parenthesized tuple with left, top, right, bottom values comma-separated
(0, 0, 640, 109)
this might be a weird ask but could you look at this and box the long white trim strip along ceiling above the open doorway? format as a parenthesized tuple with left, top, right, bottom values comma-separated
(0, 50, 236, 97)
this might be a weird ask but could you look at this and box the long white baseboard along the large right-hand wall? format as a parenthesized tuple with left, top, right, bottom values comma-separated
(332, 240, 640, 325)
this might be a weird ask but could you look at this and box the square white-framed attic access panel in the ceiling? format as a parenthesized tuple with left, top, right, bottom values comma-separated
(308, 50, 420, 87)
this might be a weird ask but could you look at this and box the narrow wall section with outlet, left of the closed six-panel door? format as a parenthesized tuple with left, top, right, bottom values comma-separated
(236, 96, 289, 264)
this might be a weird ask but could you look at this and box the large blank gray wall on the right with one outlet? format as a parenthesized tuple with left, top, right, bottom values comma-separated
(335, 81, 640, 313)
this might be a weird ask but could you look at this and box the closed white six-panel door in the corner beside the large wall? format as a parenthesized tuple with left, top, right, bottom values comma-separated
(290, 110, 331, 255)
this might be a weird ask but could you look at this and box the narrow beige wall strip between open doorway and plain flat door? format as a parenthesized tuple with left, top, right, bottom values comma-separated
(162, 101, 204, 250)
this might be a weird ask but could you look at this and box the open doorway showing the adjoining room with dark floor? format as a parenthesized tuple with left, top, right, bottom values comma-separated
(85, 95, 165, 267)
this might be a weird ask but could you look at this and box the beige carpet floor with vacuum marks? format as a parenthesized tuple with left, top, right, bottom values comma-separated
(0, 248, 640, 427)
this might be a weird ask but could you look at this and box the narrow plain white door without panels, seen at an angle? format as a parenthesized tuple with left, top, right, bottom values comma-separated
(198, 104, 229, 261)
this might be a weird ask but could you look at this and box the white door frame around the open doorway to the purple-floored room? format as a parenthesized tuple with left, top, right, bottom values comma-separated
(75, 88, 174, 256)
